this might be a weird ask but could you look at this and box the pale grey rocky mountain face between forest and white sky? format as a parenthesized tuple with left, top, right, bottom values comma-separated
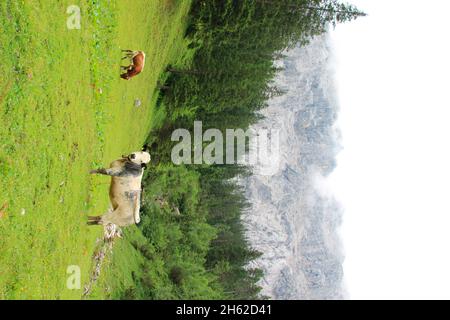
(242, 37, 344, 299)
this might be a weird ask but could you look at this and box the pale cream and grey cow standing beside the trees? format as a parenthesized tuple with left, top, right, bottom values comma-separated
(88, 151, 151, 227)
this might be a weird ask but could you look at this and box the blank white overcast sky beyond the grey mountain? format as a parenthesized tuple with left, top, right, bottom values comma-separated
(330, 0, 450, 299)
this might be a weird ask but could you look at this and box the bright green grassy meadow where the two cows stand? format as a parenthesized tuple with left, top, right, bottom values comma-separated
(0, 0, 190, 299)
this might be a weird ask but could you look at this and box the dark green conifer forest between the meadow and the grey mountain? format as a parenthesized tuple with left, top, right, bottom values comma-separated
(126, 0, 365, 299)
